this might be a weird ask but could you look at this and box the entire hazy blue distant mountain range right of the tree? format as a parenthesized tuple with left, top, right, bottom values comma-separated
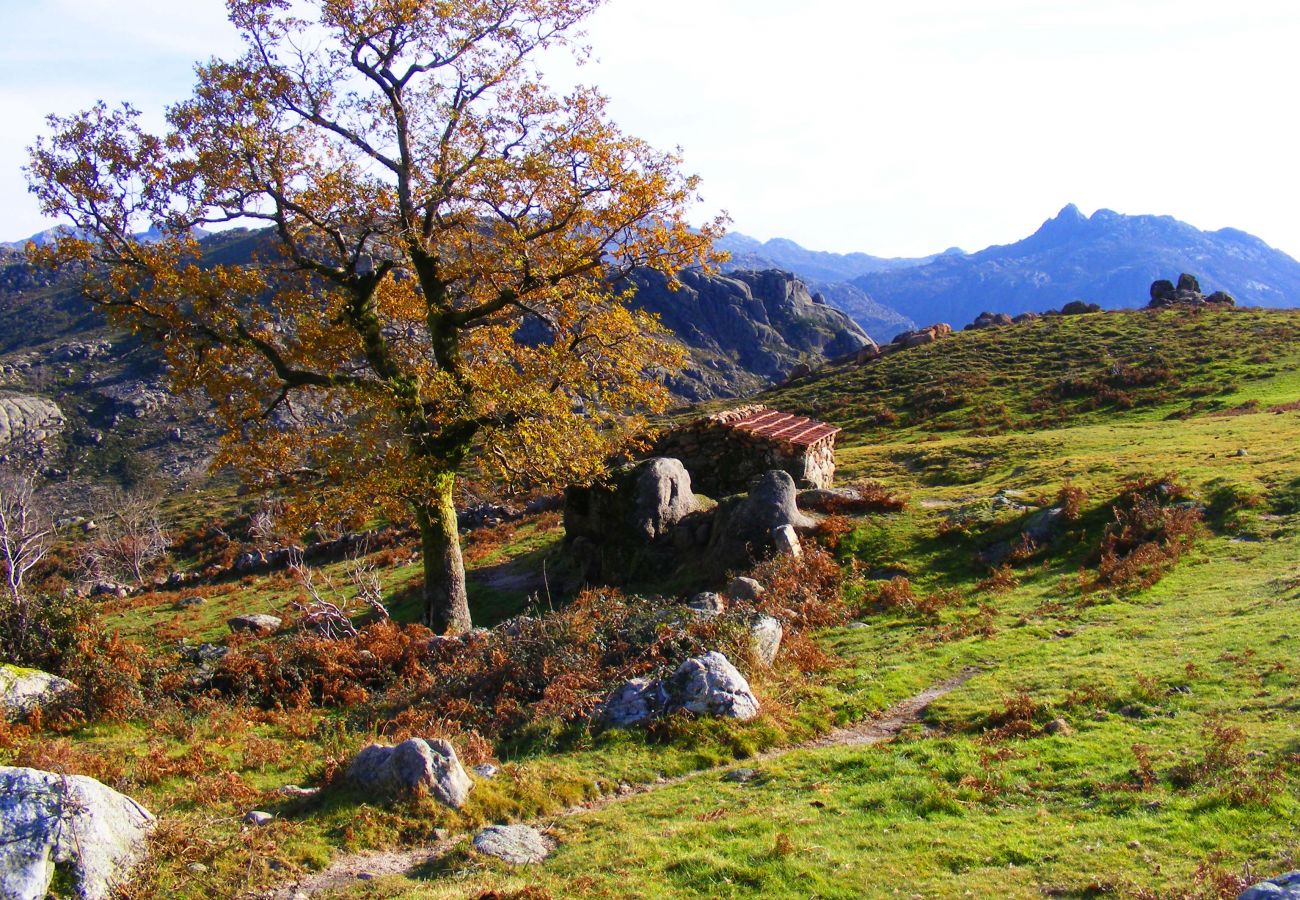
(720, 204, 1300, 341)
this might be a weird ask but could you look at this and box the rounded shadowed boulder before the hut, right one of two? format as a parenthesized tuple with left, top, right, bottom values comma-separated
(709, 470, 815, 568)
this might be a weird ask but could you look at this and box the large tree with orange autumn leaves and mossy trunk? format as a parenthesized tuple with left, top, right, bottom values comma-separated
(29, 0, 720, 632)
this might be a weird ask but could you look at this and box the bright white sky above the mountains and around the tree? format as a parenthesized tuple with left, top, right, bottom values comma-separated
(0, 0, 1300, 258)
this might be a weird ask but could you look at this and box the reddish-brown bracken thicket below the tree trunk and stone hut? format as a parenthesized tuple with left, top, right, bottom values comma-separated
(208, 546, 848, 741)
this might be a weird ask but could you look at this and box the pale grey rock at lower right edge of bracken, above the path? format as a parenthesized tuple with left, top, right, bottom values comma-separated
(599, 650, 759, 727)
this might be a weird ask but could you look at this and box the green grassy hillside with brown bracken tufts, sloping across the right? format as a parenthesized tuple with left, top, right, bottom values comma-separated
(10, 305, 1300, 899)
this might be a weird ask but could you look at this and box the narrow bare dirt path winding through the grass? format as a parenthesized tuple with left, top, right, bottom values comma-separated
(270, 668, 979, 900)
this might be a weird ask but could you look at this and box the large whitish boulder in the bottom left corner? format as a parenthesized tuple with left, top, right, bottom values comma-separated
(0, 767, 153, 900)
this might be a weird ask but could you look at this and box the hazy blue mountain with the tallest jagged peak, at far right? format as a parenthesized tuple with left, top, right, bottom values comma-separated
(852, 204, 1300, 328)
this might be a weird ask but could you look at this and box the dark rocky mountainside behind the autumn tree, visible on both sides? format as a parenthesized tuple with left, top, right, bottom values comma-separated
(0, 229, 870, 494)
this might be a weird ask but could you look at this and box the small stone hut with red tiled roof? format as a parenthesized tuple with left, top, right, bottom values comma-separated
(654, 406, 840, 497)
